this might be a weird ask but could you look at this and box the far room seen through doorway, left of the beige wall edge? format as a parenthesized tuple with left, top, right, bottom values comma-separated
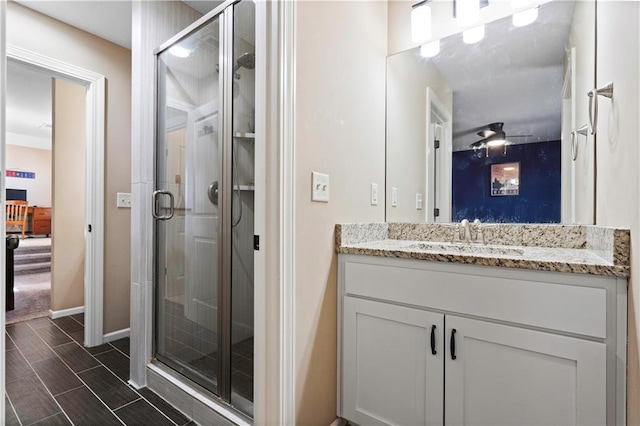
(5, 60, 53, 324)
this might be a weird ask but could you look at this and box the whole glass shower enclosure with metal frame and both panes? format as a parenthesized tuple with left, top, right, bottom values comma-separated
(152, 0, 255, 417)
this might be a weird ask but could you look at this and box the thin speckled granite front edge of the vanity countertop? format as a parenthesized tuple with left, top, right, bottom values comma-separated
(338, 247, 629, 277)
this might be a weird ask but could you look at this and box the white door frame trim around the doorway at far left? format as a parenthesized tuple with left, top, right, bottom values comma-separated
(5, 44, 106, 348)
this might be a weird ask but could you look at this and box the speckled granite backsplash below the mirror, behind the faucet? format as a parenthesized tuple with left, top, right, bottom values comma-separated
(389, 223, 587, 249)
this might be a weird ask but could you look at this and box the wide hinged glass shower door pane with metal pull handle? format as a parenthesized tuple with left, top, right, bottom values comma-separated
(153, 17, 222, 394)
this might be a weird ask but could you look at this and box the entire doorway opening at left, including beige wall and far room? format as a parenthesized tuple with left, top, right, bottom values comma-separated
(5, 60, 86, 324)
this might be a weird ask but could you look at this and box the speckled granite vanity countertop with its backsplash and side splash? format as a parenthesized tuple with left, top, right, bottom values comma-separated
(336, 223, 631, 277)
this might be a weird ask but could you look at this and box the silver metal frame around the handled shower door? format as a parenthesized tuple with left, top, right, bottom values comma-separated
(152, 0, 241, 405)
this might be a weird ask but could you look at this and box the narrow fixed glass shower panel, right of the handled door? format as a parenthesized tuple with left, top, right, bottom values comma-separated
(230, 0, 256, 414)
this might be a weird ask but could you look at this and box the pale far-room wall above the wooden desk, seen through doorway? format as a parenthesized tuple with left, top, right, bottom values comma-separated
(6, 144, 51, 207)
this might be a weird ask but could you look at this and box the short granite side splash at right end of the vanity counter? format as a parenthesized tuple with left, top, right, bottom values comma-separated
(586, 226, 631, 266)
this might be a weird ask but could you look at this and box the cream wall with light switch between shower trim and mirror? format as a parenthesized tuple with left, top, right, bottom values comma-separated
(293, 1, 387, 426)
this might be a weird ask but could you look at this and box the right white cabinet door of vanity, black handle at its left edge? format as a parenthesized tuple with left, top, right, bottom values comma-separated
(445, 315, 607, 426)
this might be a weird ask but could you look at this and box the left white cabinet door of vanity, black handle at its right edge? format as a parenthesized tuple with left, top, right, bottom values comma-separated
(342, 297, 444, 425)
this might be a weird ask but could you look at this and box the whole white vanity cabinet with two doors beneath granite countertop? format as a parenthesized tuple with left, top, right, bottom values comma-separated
(338, 254, 626, 425)
